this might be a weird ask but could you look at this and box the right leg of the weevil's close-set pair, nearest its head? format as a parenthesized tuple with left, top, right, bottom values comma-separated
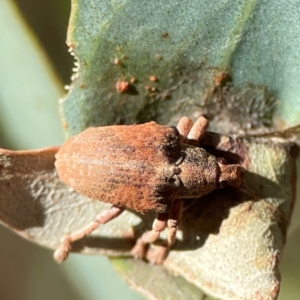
(150, 199, 183, 265)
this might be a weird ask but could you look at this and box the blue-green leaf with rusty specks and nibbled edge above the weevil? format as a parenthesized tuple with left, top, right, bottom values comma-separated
(62, 0, 300, 136)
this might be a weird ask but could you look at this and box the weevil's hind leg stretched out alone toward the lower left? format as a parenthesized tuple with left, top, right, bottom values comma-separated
(53, 205, 124, 262)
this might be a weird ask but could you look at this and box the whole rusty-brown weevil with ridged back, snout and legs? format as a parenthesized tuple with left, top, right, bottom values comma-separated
(54, 117, 242, 263)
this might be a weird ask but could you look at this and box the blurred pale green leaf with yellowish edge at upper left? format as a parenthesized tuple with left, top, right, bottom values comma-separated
(0, 1, 63, 149)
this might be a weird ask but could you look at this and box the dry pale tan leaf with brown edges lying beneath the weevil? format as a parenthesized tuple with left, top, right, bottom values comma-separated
(0, 137, 296, 300)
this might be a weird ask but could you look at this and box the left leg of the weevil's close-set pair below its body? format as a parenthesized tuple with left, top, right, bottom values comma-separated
(131, 213, 169, 258)
